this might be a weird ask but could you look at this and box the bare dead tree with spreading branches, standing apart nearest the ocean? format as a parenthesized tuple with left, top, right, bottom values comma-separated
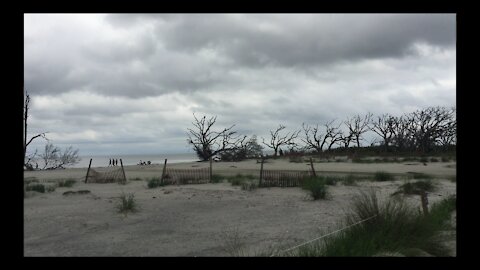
(188, 114, 246, 161)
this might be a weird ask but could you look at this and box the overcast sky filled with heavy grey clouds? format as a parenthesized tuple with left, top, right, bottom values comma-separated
(24, 14, 456, 156)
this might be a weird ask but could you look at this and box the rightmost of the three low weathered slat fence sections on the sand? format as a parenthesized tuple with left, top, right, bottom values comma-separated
(260, 170, 313, 187)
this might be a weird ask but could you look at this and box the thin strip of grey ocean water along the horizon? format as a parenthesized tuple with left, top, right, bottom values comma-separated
(68, 153, 198, 168)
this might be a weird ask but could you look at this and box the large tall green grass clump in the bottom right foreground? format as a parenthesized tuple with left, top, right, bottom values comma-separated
(292, 191, 456, 257)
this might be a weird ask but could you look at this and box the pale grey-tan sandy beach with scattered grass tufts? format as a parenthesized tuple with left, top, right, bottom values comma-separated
(24, 160, 456, 256)
